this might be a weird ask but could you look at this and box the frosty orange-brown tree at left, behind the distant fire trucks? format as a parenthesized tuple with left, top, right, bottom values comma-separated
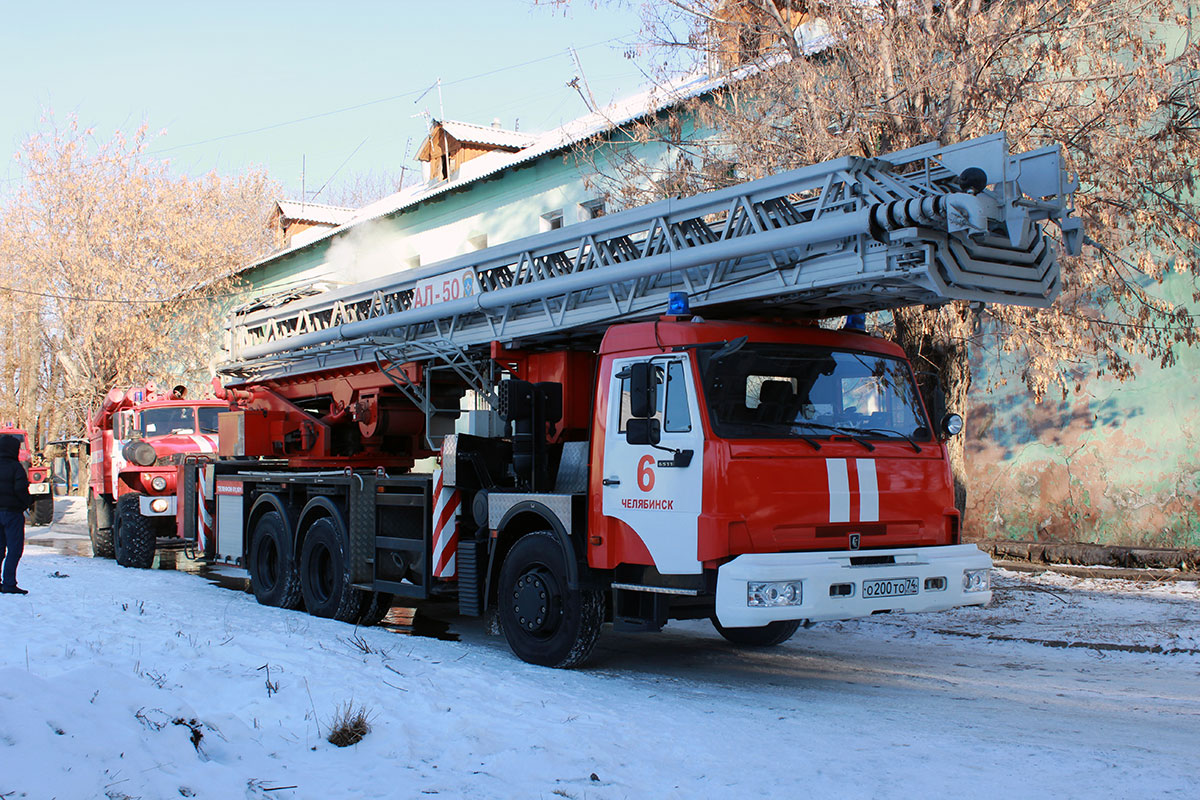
(0, 119, 277, 434)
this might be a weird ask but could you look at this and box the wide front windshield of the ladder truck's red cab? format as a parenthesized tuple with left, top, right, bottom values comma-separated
(696, 343, 930, 441)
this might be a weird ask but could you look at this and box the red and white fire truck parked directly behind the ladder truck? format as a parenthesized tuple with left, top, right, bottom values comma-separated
(88, 384, 228, 567)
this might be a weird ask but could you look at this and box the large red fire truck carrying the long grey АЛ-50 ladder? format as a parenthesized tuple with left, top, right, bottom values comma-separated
(162, 136, 1081, 667)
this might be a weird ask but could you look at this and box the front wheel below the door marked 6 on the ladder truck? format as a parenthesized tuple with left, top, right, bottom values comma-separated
(498, 530, 604, 668)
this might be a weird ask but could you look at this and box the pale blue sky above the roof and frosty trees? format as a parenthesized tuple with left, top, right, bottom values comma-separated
(0, 0, 646, 201)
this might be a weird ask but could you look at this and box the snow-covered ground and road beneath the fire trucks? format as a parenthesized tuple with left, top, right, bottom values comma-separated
(0, 499, 1200, 800)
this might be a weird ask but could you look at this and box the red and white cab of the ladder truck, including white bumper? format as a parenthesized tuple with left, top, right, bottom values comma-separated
(588, 320, 991, 639)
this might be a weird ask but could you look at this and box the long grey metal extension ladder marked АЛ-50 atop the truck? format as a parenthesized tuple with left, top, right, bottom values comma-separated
(222, 134, 1081, 380)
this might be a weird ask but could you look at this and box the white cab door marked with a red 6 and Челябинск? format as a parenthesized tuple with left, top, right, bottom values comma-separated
(601, 354, 704, 575)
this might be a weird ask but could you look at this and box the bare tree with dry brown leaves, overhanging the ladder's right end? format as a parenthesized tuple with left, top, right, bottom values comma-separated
(556, 0, 1200, 507)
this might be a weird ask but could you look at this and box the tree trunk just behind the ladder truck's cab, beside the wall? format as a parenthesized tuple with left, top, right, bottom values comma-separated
(893, 302, 976, 518)
